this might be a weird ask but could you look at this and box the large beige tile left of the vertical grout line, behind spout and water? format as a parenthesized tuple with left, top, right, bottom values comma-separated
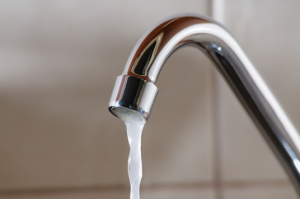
(0, 0, 212, 190)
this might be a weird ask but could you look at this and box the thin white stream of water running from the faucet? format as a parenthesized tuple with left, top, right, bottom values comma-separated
(124, 121, 145, 199)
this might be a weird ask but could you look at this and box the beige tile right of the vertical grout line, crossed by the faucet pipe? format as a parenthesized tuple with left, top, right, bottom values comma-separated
(221, 0, 300, 181)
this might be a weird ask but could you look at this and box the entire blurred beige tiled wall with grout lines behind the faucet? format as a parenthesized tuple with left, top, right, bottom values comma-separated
(0, 0, 300, 199)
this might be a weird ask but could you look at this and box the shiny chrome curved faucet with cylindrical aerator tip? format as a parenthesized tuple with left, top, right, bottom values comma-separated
(109, 15, 300, 196)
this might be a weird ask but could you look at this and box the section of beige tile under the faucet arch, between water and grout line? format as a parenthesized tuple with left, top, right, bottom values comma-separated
(142, 48, 214, 184)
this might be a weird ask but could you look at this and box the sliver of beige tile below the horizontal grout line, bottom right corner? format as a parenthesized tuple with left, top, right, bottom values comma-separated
(224, 182, 298, 199)
